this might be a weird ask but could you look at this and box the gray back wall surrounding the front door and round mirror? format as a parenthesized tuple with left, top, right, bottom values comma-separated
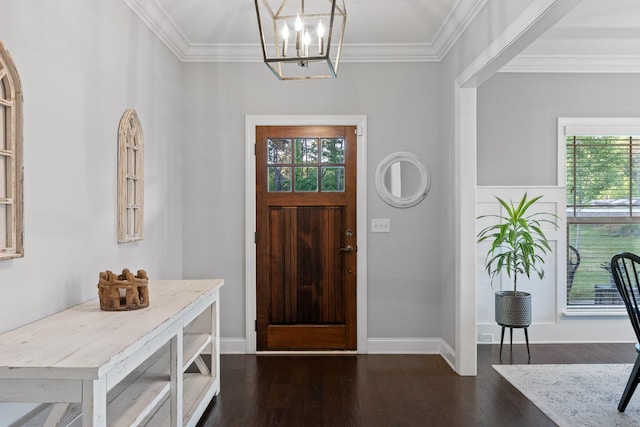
(183, 63, 446, 338)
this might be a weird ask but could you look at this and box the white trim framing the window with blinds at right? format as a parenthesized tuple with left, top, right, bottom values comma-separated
(557, 117, 640, 317)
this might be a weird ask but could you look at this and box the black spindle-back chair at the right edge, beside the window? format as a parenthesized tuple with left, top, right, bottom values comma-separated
(611, 252, 640, 412)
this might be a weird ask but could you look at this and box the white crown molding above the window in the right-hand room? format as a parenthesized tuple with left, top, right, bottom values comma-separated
(499, 55, 640, 73)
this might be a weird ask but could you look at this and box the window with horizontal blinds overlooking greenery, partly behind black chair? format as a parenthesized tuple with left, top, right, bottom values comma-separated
(566, 135, 640, 308)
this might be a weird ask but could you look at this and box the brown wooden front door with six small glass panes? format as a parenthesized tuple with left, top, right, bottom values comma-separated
(256, 126, 357, 351)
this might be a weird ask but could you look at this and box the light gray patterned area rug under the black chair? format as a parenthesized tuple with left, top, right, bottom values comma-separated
(493, 364, 640, 427)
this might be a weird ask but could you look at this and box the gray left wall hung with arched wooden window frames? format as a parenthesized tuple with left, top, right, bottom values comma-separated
(0, 0, 183, 425)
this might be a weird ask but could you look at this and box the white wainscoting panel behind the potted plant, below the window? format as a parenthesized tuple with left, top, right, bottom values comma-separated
(476, 186, 634, 343)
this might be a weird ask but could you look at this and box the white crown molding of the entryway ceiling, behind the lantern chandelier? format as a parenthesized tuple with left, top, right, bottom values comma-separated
(123, 0, 488, 62)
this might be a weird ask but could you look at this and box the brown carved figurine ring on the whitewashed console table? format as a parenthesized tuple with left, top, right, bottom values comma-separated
(98, 268, 149, 311)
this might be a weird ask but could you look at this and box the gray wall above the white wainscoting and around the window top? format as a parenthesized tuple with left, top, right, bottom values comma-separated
(478, 73, 640, 185)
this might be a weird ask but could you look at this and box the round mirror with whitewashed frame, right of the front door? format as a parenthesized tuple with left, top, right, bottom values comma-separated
(376, 151, 431, 208)
